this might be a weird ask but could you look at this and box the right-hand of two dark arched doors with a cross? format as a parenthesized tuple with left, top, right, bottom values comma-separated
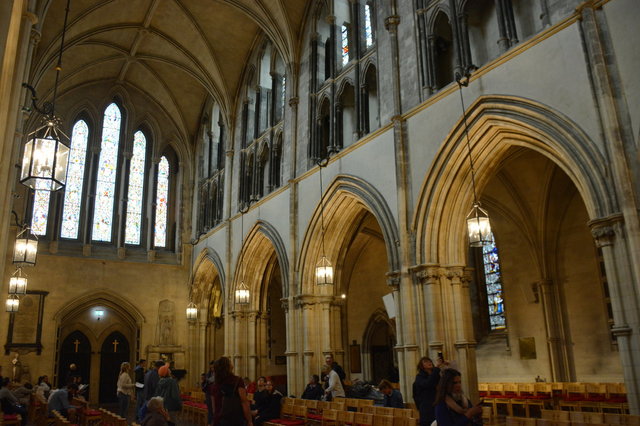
(99, 331, 131, 403)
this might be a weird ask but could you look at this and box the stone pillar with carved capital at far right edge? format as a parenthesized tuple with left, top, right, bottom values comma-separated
(589, 214, 640, 415)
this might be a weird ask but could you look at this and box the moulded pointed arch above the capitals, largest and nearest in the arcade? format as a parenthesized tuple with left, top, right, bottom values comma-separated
(413, 96, 618, 264)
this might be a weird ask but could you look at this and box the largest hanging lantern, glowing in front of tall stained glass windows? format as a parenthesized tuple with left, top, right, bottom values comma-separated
(20, 116, 69, 191)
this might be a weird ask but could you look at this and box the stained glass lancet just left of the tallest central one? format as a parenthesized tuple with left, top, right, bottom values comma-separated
(60, 120, 89, 239)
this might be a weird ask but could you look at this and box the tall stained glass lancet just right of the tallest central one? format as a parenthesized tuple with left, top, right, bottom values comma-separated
(124, 130, 147, 244)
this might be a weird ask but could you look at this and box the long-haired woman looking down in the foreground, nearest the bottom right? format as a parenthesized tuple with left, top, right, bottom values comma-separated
(436, 368, 482, 426)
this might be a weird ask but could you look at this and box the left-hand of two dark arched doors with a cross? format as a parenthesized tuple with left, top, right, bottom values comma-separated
(57, 330, 91, 392)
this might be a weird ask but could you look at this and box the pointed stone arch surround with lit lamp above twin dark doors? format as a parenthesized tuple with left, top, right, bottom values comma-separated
(53, 289, 146, 403)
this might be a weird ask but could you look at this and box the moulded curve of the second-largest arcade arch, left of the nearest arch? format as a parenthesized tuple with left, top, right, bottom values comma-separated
(298, 175, 400, 294)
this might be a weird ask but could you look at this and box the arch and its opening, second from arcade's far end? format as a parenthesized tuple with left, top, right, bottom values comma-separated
(227, 220, 289, 384)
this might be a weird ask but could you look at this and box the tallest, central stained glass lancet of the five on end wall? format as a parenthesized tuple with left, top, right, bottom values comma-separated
(92, 103, 122, 242)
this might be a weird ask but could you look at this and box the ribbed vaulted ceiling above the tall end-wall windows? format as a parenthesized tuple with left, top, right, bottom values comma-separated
(30, 0, 311, 148)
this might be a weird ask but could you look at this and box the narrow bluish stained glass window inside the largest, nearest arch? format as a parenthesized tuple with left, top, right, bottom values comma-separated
(482, 234, 507, 330)
